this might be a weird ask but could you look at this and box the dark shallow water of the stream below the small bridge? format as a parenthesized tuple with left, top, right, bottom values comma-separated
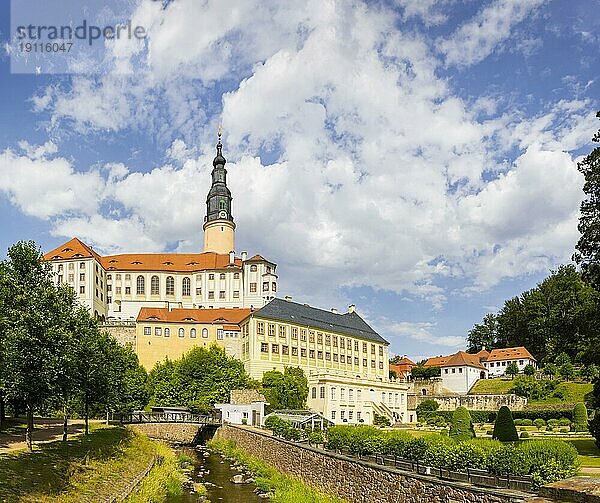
(167, 446, 268, 503)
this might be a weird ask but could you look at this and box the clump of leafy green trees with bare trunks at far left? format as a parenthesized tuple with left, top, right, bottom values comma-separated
(0, 241, 145, 448)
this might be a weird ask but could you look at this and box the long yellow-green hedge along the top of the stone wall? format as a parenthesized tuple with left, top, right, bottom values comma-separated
(327, 426, 578, 487)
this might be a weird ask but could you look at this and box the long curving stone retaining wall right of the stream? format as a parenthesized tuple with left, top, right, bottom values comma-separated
(215, 424, 529, 503)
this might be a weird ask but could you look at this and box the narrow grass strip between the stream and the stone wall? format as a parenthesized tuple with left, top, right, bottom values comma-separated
(208, 440, 344, 503)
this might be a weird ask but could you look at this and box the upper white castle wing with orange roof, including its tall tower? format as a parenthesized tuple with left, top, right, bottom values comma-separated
(44, 138, 278, 321)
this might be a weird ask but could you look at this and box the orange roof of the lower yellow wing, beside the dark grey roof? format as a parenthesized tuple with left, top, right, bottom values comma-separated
(137, 307, 250, 322)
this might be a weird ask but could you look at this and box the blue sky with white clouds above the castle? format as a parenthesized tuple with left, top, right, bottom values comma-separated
(0, 0, 600, 358)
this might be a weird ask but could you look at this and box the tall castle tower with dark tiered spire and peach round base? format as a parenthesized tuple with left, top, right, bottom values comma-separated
(204, 131, 235, 254)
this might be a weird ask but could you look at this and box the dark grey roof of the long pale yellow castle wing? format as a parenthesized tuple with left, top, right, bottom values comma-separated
(253, 299, 389, 344)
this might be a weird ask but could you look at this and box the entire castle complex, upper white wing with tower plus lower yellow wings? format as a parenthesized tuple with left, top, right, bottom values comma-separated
(44, 136, 408, 424)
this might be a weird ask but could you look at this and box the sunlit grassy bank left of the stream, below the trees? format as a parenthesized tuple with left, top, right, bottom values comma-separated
(0, 427, 183, 503)
